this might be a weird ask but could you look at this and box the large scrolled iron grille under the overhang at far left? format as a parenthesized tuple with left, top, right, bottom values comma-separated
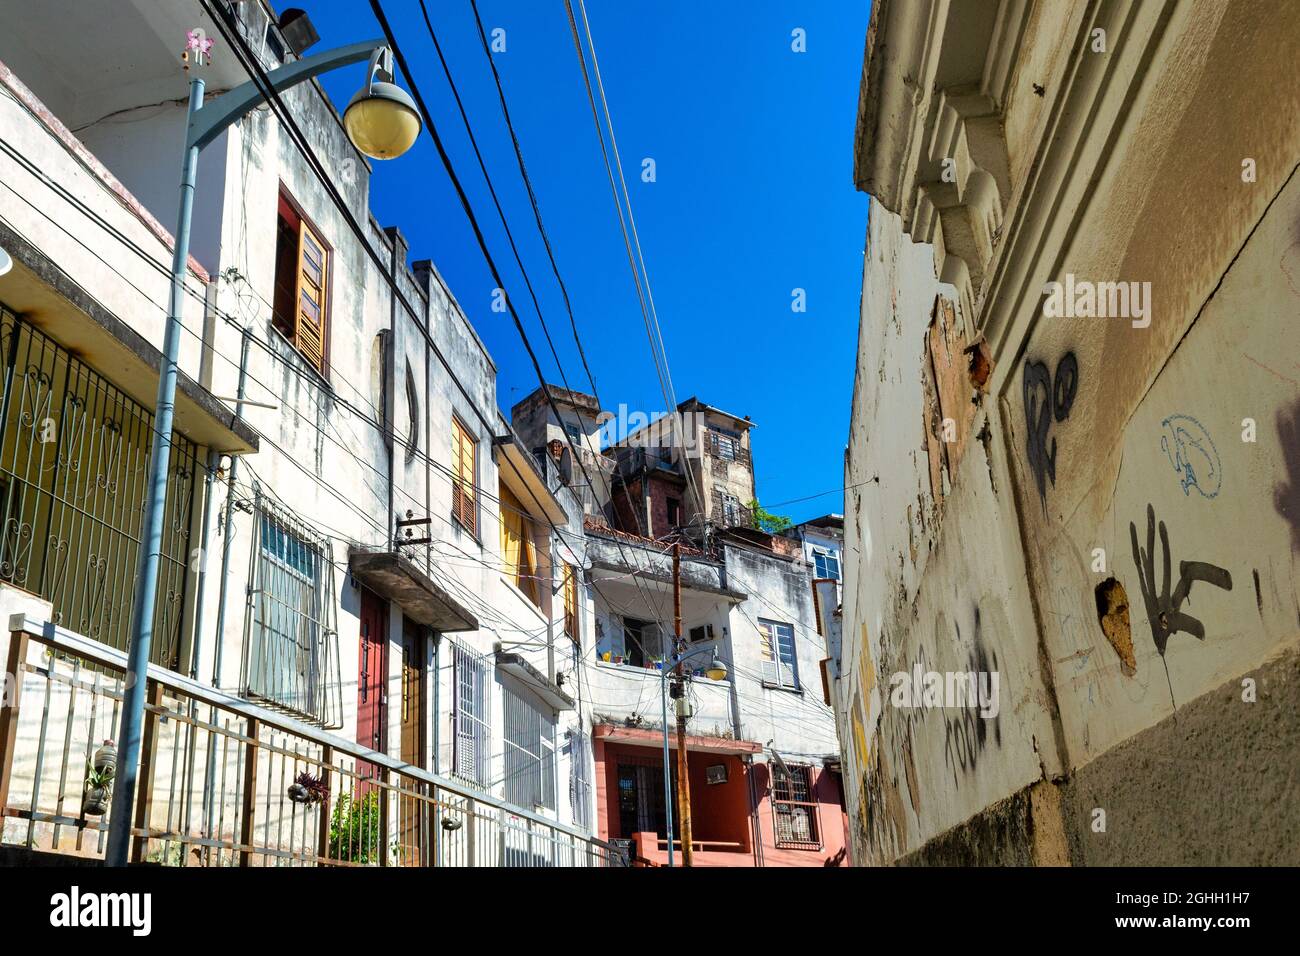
(0, 307, 198, 670)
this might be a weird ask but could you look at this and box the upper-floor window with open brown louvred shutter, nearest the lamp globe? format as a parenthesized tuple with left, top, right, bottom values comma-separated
(272, 193, 330, 375)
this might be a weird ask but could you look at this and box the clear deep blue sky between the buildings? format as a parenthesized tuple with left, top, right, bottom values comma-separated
(303, 0, 870, 520)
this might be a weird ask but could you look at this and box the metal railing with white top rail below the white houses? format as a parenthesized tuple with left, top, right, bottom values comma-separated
(0, 615, 627, 866)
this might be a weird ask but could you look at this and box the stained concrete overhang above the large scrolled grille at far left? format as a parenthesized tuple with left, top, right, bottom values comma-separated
(0, 222, 257, 455)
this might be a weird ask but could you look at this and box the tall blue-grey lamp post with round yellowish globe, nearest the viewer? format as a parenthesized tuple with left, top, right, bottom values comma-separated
(105, 33, 421, 866)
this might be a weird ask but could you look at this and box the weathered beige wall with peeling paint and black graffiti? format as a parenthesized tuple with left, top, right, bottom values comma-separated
(837, 3, 1300, 864)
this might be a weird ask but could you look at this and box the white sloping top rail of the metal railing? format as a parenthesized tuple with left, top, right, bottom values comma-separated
(9, 614, 618, 852)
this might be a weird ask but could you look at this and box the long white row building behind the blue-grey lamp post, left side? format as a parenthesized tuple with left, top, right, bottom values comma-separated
(0, 0, 608, 865)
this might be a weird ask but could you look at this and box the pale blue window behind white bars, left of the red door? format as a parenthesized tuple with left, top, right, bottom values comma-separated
(243, 497, 343, 727)
